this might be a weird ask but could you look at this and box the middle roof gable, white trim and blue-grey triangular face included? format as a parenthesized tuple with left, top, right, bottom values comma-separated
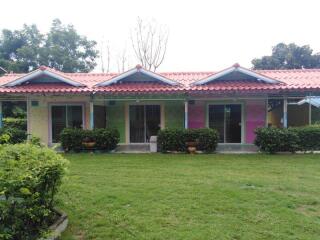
(96, 65, 179, 87)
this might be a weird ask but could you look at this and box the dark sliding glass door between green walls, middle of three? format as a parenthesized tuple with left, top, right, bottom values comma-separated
(129, 105, 161, 143)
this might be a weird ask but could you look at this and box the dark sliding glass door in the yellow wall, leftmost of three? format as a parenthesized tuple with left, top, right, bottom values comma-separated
(51, 105, 83, 143)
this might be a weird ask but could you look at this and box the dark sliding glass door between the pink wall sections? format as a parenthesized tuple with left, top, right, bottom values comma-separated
(209, 104, 242, 143)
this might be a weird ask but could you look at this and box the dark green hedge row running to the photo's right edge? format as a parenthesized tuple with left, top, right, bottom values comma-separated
(255, 125, 320, 153)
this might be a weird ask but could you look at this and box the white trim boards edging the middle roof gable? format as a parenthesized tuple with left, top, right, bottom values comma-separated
(96, 66, 178, 87)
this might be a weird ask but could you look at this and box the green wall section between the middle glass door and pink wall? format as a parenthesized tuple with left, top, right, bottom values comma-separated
(164, 101, 184, 128)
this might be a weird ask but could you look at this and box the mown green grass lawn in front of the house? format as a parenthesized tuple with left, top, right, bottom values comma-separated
(58, 154, 320, 240)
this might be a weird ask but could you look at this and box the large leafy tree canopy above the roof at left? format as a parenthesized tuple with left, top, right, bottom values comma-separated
(0, 19, 98, 73)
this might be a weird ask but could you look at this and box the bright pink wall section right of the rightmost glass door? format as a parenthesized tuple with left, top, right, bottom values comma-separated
(245, 100, 266, 143)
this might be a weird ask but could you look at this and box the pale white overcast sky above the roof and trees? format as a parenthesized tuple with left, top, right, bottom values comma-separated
(0, 0, 320, 72)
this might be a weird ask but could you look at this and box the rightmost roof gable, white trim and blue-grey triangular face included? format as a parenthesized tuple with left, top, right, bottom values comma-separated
(192, 63, 280, 85)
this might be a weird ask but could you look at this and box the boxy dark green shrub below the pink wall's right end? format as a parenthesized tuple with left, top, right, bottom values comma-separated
(255, 127, 299, 153)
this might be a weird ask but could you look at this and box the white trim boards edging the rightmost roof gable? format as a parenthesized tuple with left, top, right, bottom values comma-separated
(192, 66, 280, 85)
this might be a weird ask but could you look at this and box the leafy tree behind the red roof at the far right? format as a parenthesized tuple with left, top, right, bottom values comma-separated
(252, 43, 320, 69)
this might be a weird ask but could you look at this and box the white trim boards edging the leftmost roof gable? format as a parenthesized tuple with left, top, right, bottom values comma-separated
(3, 69, 85, 87)
